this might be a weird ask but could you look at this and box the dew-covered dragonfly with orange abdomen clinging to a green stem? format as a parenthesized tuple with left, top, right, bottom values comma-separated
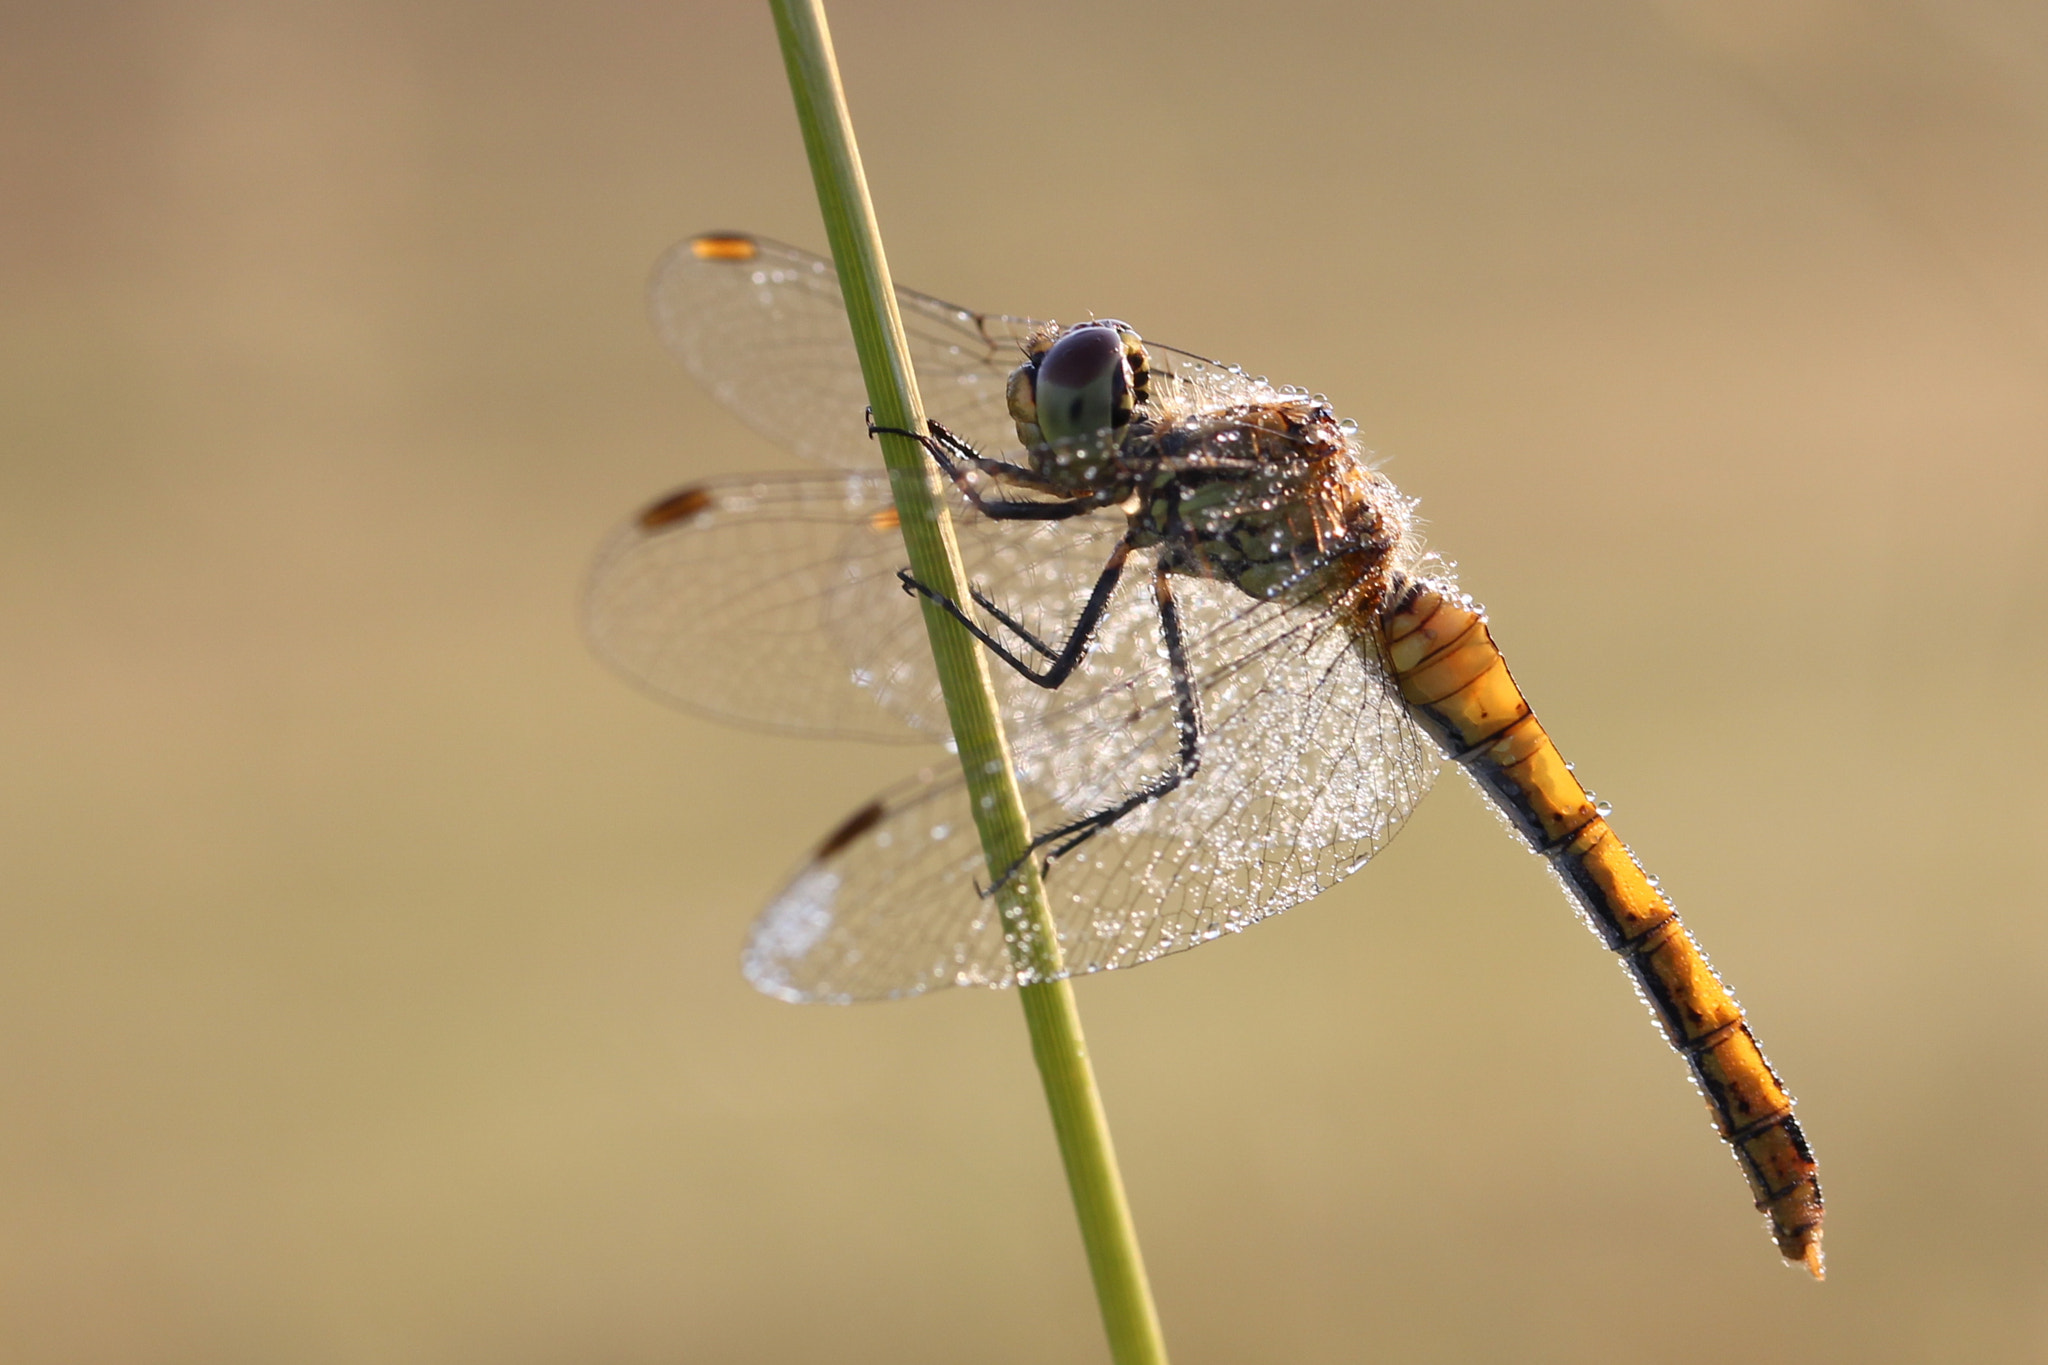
(584, 233, 1823, 1277)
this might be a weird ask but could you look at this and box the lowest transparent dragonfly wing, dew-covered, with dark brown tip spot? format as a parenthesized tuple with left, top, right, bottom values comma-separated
(745, 573, 1438, 1001)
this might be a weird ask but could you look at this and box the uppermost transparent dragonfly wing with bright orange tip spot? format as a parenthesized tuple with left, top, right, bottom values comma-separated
(647, 233, 1038, 469)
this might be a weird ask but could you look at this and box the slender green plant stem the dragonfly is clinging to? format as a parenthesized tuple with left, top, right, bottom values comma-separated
(770, 0, 1165, 1365)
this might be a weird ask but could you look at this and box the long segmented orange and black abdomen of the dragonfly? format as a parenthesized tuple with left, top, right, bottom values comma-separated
(1380, 581, 1821, 1275)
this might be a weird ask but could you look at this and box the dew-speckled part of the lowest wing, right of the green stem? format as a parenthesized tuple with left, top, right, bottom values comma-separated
(1020, 579, 1440, 972)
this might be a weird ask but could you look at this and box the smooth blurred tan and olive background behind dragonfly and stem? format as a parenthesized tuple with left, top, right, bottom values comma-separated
(0, 0, 2048, 1365)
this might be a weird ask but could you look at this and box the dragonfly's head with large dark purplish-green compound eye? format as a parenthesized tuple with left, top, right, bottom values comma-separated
(1008, 317, 1151, 446)
